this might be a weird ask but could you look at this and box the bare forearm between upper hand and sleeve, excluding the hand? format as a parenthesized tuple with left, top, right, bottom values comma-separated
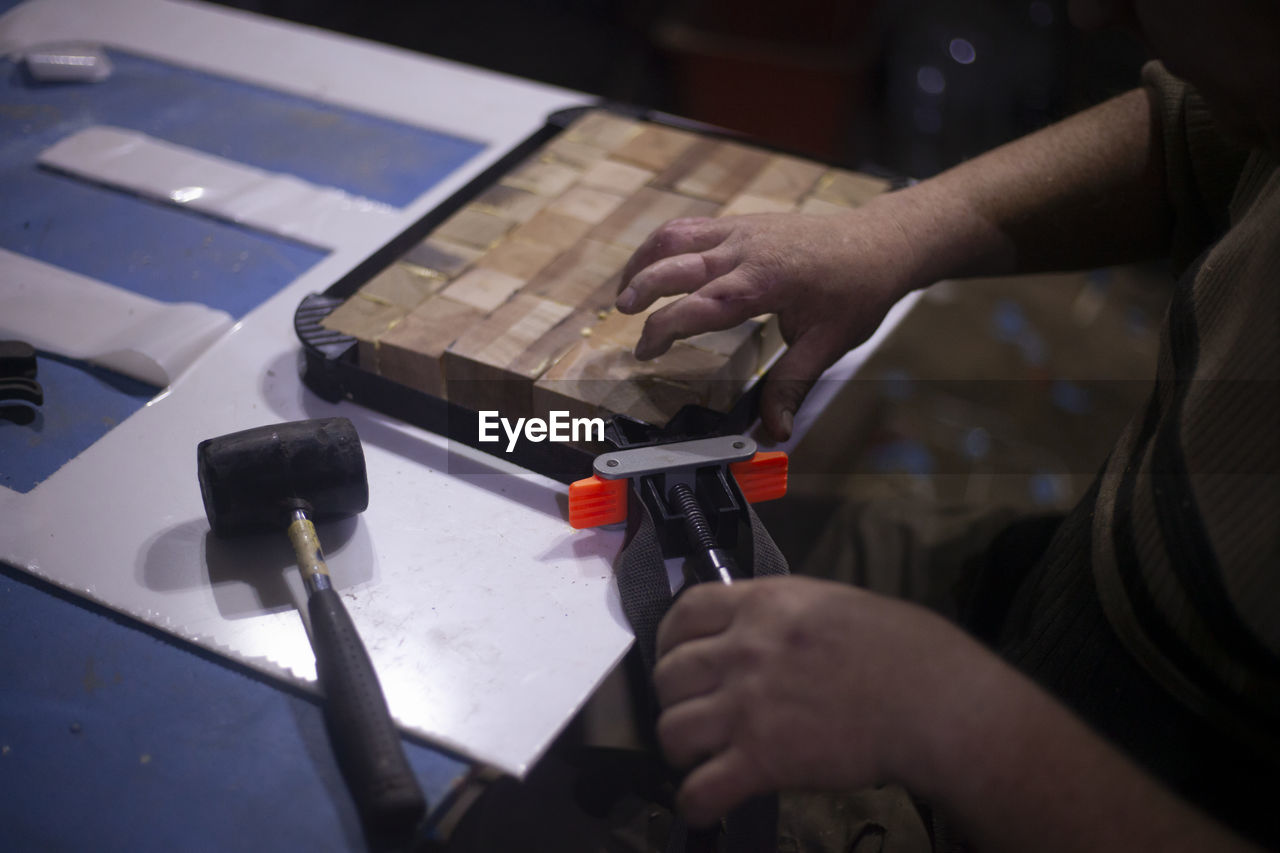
(872, 90, 1171, 283)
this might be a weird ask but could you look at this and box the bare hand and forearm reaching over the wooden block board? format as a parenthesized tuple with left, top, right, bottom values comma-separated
(618, 90, 1172, 438)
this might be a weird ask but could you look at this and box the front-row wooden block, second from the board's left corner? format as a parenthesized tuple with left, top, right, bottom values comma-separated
(376, 295, 483, 397)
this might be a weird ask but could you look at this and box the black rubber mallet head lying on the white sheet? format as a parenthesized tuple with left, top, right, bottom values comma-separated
(196, 418, 369, 537)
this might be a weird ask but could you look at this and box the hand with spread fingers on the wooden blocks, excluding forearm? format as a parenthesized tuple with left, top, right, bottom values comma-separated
(618, 202, 928, 439)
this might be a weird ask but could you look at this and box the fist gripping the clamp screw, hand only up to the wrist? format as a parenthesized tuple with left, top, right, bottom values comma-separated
(654, 578, 991, 824)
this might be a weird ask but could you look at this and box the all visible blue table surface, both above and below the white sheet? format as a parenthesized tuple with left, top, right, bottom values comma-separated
(0, 26, 483, 850)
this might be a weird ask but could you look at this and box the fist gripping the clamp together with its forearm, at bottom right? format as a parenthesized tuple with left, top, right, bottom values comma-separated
(653, 576, 1256, 853)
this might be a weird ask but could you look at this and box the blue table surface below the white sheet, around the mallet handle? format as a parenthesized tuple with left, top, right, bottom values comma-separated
(0, 564, 468, 850)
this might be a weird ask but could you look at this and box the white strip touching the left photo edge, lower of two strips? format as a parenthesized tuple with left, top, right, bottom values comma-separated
(0, 250, 233, 387)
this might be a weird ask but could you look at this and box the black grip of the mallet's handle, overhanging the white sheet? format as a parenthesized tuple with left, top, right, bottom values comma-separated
(307, 588, 426, 839)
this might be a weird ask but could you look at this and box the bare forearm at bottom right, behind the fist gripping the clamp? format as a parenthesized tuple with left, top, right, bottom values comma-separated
(904, 645, 1256, 853)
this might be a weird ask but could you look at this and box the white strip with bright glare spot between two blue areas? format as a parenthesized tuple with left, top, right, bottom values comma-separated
(40, 126, 397, 250)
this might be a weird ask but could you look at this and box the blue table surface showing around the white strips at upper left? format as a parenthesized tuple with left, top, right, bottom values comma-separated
(0, 51, 484, 492)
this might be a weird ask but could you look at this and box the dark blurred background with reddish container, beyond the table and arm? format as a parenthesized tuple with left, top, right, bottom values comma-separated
(209, 0, 1144, 177)
